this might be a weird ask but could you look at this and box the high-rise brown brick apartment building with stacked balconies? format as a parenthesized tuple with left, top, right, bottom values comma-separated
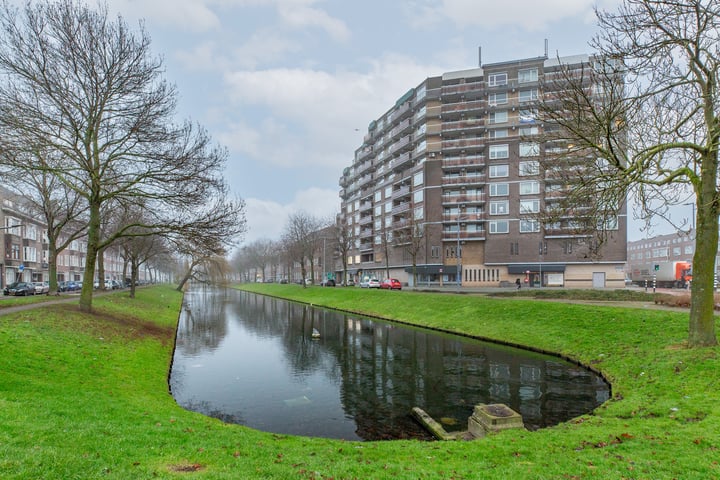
(339, 55, 626, 287)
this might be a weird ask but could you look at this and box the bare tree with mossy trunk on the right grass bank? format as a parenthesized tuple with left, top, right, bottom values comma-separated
(542, 0, 720, 347)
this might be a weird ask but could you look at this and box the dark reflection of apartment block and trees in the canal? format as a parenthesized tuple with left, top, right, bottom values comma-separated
(173, 293, 609, 440)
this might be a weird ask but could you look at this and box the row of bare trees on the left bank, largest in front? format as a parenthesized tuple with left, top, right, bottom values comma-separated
(0, 0, 246, 311)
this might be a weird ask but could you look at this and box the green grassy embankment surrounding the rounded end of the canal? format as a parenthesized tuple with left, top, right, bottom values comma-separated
(0, 285, 720, 479)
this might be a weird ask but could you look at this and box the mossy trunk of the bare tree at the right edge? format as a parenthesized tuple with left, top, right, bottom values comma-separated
(688, 156, 720, 347)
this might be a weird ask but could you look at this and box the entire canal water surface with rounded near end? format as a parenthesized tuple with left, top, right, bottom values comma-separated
(170, 288, 609, 440)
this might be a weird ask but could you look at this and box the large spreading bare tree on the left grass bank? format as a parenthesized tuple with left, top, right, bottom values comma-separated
(0, 0, 242, 311)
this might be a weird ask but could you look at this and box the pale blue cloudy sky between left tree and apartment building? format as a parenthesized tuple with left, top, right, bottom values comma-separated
(90, 0, 688, 243)
